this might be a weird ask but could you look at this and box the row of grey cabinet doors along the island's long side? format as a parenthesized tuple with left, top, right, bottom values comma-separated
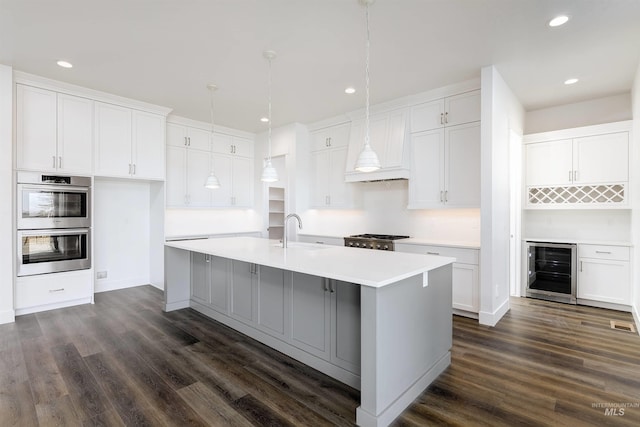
(191, 252, 360, 375)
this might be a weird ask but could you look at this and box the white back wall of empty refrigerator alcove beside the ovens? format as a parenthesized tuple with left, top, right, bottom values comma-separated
(93, 178, 151, 292)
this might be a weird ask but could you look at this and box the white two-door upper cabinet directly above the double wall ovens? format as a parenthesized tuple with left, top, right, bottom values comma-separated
(16, 84, 93, 175)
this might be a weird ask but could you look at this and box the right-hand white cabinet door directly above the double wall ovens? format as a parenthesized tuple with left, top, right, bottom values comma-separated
(58, 94, 93, 175)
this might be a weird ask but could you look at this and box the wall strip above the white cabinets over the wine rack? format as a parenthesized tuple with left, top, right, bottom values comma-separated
(524, 93, 632, 134)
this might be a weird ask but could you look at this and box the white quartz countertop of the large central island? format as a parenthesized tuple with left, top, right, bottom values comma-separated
(165, 237, 455, 288)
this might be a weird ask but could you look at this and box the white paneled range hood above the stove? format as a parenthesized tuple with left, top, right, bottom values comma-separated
(344, 108, 411, 182)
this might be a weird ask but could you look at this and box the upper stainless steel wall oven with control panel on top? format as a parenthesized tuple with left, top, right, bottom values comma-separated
(17, 172, 91, 230)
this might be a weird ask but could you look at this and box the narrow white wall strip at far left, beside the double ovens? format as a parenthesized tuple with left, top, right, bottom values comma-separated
(0, 65, 15, 324)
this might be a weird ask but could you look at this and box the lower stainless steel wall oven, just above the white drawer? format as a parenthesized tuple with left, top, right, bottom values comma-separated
(18, 228, 91, 276)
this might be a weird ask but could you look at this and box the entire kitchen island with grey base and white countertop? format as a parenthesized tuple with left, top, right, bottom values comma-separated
(164, 237, 455, 426)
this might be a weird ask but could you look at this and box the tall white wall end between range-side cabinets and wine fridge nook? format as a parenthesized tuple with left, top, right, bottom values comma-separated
(479, 66, 524, 326)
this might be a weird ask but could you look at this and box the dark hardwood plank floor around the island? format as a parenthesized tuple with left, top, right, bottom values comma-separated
(0, 286, 640, 427)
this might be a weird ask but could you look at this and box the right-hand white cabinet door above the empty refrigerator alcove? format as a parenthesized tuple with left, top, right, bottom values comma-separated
(131, 110, 165, 180)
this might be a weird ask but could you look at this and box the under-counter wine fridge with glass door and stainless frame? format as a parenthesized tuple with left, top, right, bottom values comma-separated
(526, 242, 577, 304)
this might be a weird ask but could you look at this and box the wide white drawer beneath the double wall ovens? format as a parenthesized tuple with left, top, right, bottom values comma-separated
(16, 270, 93, 309)
